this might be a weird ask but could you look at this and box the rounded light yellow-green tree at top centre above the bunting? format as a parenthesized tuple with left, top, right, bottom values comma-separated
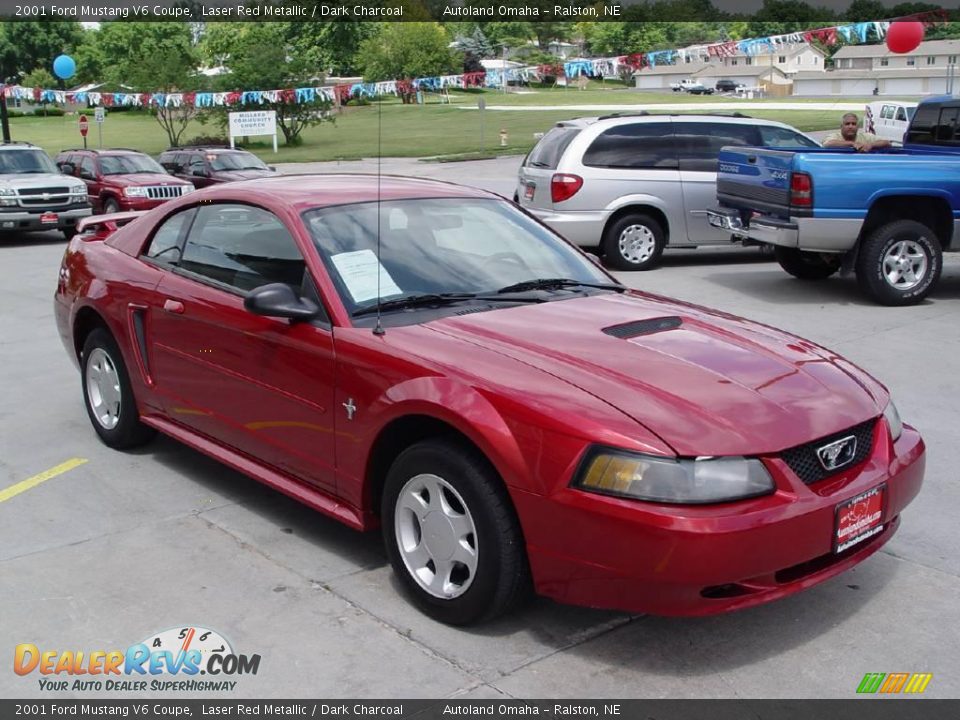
(359, 22, 463, 81)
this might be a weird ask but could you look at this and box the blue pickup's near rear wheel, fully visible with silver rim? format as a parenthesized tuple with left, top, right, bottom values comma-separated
(857, 220, 943, 305)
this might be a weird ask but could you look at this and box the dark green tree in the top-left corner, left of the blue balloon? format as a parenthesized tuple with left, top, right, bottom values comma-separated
(0, 22, 83, 83)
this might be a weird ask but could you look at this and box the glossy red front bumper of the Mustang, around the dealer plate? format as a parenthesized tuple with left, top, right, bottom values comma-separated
(515, 421, 925, 615)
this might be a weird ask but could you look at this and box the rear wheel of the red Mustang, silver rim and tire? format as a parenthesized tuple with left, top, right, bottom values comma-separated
(80, 328, 155, 449)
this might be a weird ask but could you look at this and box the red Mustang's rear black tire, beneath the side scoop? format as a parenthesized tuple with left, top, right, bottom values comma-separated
(80, 328, 156, 450)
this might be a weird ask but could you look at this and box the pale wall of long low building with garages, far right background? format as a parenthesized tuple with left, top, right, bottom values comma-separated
(793, 67, 958, 97)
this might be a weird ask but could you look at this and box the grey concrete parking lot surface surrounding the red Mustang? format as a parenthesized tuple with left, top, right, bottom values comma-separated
(0, 158, 960, 699)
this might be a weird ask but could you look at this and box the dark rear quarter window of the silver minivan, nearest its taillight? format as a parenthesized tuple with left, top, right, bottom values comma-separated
(583, 122, 677, 170)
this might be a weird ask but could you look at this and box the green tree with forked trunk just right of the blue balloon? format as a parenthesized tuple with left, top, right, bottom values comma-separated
(91, 22, 203, 145)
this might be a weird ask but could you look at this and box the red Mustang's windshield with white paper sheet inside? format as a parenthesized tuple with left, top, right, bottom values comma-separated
(304, 198, 611, 312)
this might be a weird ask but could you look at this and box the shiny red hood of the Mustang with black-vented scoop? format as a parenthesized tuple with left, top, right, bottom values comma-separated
(425, 293, 887, 457)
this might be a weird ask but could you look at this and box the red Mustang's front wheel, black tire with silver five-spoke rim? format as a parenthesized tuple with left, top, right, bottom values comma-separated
(380, 439, 530, 625)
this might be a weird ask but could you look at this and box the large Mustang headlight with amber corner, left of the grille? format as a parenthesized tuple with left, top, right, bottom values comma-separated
(573, 448, 774, 505)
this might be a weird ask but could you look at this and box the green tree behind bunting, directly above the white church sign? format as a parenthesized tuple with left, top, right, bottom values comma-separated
(203, 22, 334, 145)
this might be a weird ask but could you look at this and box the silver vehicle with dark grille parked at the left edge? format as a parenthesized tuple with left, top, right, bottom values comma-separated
(0, 142, 93, 240)
